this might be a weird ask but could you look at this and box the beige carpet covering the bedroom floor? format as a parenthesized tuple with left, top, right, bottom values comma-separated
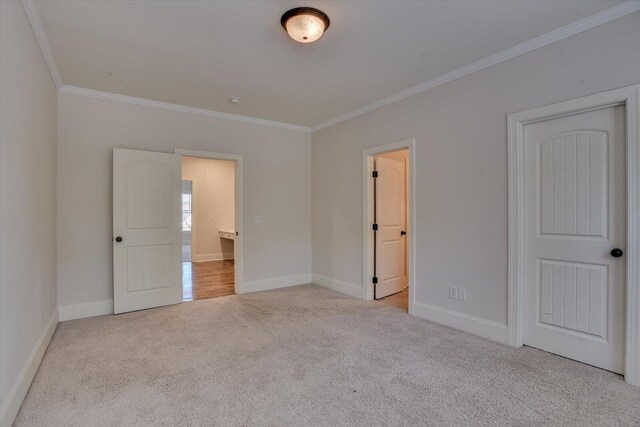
(16, 285, 640, 426)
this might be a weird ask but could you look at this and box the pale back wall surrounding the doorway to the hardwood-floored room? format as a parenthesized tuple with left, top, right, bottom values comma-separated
(58, 94, 311, 317)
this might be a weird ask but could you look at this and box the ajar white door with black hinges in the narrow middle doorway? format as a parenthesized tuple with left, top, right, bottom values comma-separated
(375, 156, 407, 299)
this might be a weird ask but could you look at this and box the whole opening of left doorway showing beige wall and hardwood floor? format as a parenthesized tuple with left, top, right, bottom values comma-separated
(182, 156, 236, 301)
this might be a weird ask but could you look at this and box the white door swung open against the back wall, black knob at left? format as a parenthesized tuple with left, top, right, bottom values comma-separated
(113, 148, 182, 314)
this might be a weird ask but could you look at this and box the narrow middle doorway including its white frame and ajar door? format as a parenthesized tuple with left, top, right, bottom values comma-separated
(364, 140, 415, 313)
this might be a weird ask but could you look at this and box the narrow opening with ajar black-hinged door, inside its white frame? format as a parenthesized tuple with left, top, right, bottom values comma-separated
(373, 149, 409, 311)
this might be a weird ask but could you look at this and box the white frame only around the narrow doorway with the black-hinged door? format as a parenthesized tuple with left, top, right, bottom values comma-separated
(362, 138, 416, 314)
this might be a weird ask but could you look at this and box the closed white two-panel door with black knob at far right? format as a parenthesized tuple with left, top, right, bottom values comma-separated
(524, 106, 626, 373)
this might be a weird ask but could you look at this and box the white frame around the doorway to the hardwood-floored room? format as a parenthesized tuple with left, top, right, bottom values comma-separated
(174, 148, 244, 294)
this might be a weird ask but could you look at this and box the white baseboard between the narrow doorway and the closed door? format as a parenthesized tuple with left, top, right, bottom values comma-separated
(413, 301, 507, 344)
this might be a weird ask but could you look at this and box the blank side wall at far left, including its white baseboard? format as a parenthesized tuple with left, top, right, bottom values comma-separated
(0, 1, 58, 426)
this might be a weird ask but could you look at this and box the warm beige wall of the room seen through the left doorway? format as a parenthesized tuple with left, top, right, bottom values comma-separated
(182, 157, 236, 262)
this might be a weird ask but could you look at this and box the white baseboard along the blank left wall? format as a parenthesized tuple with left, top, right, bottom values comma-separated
(0, 309, 58, 427)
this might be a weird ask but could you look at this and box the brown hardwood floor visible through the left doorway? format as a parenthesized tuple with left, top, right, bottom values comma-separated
(182, 260, 235, 301)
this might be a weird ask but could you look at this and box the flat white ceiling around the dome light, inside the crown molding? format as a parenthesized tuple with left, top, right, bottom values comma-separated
(36, 0, 620, 126)
